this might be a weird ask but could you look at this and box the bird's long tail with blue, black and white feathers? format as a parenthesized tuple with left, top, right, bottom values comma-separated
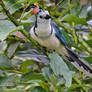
(66, 47, 92, 77)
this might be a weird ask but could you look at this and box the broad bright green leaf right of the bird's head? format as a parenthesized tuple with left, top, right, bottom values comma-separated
(62, 14, 87, 25)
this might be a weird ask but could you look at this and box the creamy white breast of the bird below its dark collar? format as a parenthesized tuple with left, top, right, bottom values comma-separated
(30, 27, 60, 49)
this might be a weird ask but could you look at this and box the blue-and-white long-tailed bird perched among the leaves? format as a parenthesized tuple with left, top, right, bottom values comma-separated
(29, 7, 92, 77)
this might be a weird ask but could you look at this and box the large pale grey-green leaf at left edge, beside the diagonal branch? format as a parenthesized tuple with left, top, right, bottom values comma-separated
(0, 20, 15, 40)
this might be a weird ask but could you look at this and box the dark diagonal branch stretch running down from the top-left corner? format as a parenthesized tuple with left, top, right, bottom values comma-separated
(0, 0, 19, 26)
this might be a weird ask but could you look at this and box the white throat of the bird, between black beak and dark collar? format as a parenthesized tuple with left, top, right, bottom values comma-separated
(35, 20, 51, 38)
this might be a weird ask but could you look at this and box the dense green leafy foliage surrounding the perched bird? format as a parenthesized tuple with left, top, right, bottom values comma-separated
(0, 0, 92, 92)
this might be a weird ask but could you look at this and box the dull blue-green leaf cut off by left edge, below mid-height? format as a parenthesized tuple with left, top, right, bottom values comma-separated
(0, 55, 12, 69)
